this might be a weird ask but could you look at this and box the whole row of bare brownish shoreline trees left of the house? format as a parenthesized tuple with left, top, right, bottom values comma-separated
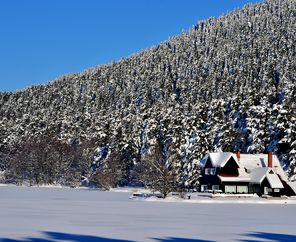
(0, 132, 194, 196)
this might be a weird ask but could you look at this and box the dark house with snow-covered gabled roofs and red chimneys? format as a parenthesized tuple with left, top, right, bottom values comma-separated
(199, 152, 295, 196)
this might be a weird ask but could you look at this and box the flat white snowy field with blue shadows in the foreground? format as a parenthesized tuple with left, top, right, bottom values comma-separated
(0, 186, 296, 242)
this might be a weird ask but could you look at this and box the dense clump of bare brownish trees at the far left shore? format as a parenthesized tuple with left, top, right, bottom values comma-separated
(0, 136, 90, 187)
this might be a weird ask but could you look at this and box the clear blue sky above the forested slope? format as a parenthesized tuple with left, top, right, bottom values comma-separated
(0, 0, 260, 91)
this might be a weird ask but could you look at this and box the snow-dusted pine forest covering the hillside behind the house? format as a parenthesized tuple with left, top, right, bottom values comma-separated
(0, 0, 296, 190)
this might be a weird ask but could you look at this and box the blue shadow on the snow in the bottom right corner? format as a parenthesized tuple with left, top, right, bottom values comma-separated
(240, 232, 296, 242)
